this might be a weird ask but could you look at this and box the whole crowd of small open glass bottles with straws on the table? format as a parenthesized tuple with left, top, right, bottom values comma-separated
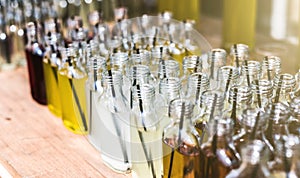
(19, 2, 300, 177)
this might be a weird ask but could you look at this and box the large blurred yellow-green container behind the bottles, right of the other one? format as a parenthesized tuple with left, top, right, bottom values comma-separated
(223, 0, 256, 50)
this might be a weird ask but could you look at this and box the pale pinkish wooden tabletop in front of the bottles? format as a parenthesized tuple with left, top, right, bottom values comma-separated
(0, 68, 131, 177)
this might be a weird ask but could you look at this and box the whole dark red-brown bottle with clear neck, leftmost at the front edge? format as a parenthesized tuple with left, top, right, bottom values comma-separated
(25, 22, 47, 105)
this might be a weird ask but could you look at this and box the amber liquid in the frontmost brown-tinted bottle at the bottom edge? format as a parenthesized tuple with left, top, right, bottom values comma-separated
(163, 139, 203, 178)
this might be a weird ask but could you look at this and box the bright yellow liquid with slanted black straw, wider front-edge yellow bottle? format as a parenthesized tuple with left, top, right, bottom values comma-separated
(58, 69, 88, 134)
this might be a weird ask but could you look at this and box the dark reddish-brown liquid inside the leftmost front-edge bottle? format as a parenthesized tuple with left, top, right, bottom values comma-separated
(25, 48, 47, 105)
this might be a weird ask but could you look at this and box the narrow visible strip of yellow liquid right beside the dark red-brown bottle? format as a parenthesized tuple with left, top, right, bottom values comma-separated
(43, 62, 61, 117)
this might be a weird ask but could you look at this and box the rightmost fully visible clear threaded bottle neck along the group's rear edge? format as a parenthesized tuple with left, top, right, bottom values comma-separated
(260, 56, 281, 82)
